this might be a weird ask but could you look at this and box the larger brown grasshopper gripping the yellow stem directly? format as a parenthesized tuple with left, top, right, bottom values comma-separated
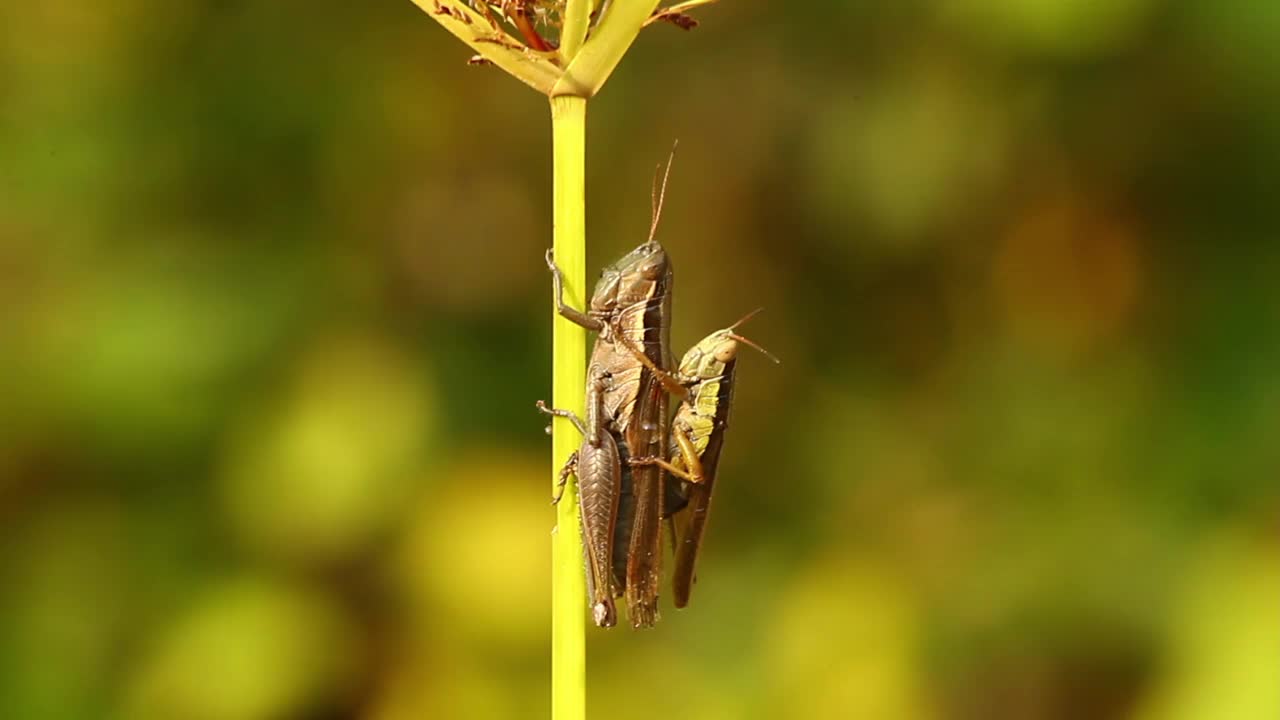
(547, 155, 672, 628)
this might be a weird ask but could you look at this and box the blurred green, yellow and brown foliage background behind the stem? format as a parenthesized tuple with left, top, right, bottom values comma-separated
(0, 0, 1280, 720)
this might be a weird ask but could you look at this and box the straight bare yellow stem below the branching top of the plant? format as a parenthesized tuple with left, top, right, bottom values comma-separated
(550, 95, 586, 720)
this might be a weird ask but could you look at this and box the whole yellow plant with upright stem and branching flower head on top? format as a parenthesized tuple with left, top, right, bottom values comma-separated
(412, 0, 714, 720)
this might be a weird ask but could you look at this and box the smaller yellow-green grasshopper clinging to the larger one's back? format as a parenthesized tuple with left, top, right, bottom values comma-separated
(623, 310, 778, 607)
